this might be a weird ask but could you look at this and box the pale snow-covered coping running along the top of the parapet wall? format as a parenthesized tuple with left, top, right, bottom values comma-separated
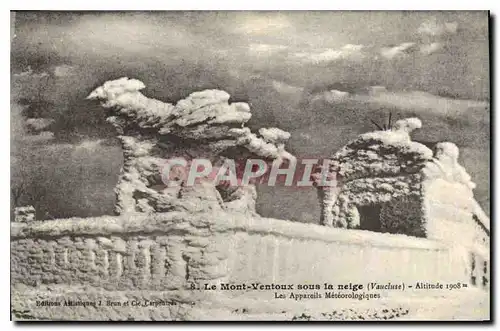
(11, 211, 445, 249)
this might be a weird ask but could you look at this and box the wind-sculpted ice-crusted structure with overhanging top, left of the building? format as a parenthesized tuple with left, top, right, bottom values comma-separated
(87, 77, 294, 214)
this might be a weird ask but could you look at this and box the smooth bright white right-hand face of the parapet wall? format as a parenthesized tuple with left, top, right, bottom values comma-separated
(228, 230, 468, 296)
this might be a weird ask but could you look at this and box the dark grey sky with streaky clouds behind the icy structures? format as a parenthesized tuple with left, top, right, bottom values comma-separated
(11, 12, 490, 221)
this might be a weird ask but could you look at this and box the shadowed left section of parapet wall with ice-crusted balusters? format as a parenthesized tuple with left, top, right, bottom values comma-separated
(11, 213, 227, 290)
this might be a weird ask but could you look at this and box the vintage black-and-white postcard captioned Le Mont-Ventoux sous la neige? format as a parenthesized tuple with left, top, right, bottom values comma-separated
(10, 11, 491, 322)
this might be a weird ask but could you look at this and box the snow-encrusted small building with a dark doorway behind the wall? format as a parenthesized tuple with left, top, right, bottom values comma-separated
(318, 118, 490, 285)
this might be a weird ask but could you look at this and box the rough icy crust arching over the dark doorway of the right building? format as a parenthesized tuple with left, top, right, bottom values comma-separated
(318, 118, 433, 234)
